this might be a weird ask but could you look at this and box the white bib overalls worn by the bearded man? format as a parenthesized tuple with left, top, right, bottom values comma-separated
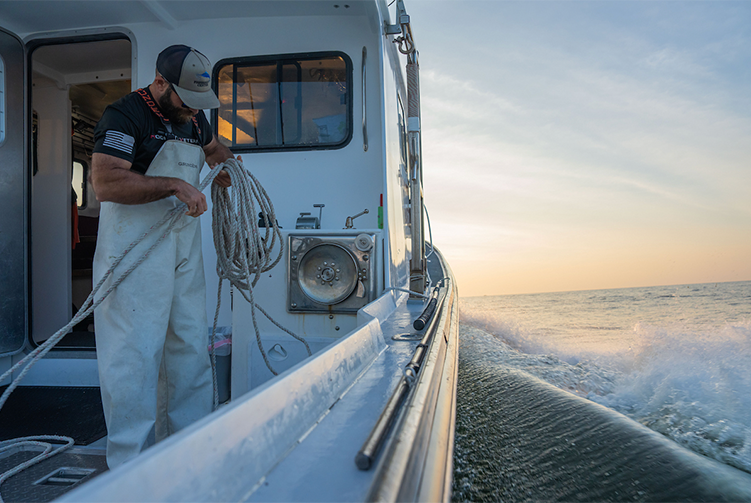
(93, 140, 213, 468)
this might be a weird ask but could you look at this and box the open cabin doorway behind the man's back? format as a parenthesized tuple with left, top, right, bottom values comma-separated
(30, 37, 133, 350)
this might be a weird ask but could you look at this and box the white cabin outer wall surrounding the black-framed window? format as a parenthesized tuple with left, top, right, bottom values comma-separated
(123, 13, 385, 360)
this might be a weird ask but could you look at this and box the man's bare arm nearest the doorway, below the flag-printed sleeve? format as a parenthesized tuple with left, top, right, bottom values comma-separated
(91, 153, 209, 217)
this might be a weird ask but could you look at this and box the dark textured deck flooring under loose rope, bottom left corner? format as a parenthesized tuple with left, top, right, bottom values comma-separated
(0, 451, 107, 503)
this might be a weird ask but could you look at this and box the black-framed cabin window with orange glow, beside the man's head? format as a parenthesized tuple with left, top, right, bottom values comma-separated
(213, 53, 352, 151)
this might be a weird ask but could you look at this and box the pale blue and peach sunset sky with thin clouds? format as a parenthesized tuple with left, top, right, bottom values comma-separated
(405, 0, 751, 296)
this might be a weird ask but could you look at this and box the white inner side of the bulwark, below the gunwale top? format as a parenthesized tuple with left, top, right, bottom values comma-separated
(55, 316, 386, 502)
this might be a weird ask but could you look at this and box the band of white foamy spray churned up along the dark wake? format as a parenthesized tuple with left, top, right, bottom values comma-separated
(461, 309, 751, 473)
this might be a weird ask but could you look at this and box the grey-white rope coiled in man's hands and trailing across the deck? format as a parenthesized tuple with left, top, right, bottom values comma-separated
(0, 159, 312, 503)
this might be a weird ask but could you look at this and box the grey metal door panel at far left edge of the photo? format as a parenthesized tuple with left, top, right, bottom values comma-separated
(0, 29, 27, 355)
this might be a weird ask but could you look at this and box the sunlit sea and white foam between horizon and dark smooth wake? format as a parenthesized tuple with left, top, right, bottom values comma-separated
(461, 288, 751, 473)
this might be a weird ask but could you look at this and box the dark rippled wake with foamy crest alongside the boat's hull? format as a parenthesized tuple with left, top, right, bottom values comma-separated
(454, 326, 751, 501)
